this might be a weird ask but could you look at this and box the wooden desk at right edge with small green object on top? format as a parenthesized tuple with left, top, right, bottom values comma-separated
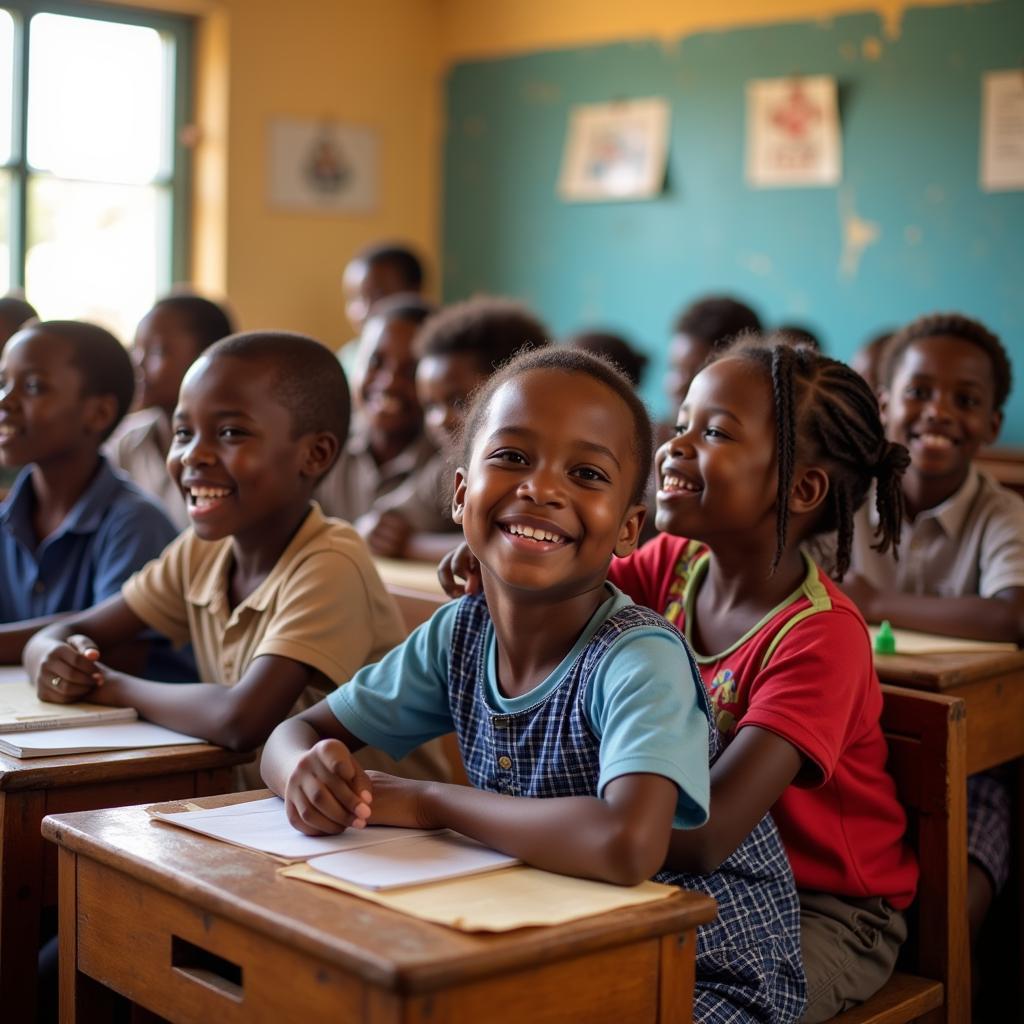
(874, 650, 1024, 775)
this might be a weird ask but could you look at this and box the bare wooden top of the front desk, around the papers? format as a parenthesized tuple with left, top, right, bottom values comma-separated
(43, 797, 715, 993)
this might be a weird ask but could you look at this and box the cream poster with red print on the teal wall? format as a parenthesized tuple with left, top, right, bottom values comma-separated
(746, 75, 843, 188)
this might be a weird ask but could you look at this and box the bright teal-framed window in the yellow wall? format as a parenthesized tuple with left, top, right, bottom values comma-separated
(0, 0, 190, 341)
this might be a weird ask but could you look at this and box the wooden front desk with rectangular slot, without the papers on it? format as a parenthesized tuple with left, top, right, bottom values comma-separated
(43, 799, 714, 1024)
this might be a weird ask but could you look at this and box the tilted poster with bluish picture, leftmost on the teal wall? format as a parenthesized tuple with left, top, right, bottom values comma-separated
(558, 97, 669, 202)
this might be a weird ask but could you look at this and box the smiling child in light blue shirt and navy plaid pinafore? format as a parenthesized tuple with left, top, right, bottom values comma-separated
(262, 348, 804, 1024)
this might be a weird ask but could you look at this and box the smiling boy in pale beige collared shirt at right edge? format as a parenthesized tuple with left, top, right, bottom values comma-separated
(843, 313, 1024, 958)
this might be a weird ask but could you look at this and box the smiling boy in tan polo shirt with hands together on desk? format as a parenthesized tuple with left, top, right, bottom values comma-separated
(25, 332, 445, 784)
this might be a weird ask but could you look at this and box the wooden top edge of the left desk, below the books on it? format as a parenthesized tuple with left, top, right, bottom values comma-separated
(0, 743, 256, 793)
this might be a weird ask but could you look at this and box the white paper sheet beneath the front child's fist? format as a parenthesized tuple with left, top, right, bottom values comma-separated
(153, 797, 442, 860)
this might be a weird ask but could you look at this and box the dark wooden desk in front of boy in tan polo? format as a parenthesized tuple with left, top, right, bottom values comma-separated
(0, 743, 252, 1021)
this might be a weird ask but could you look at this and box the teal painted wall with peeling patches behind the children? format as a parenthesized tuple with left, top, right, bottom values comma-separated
(443, 0, 1024, 444)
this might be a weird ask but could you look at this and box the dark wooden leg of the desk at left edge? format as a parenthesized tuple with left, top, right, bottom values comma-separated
(0, 792, 44, 1021)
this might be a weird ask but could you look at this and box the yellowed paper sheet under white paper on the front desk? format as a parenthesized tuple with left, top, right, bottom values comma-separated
(281, 864, 679, 932)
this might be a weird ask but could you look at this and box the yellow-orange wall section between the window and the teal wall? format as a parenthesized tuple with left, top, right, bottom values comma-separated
(115, 0, 441, 347)
